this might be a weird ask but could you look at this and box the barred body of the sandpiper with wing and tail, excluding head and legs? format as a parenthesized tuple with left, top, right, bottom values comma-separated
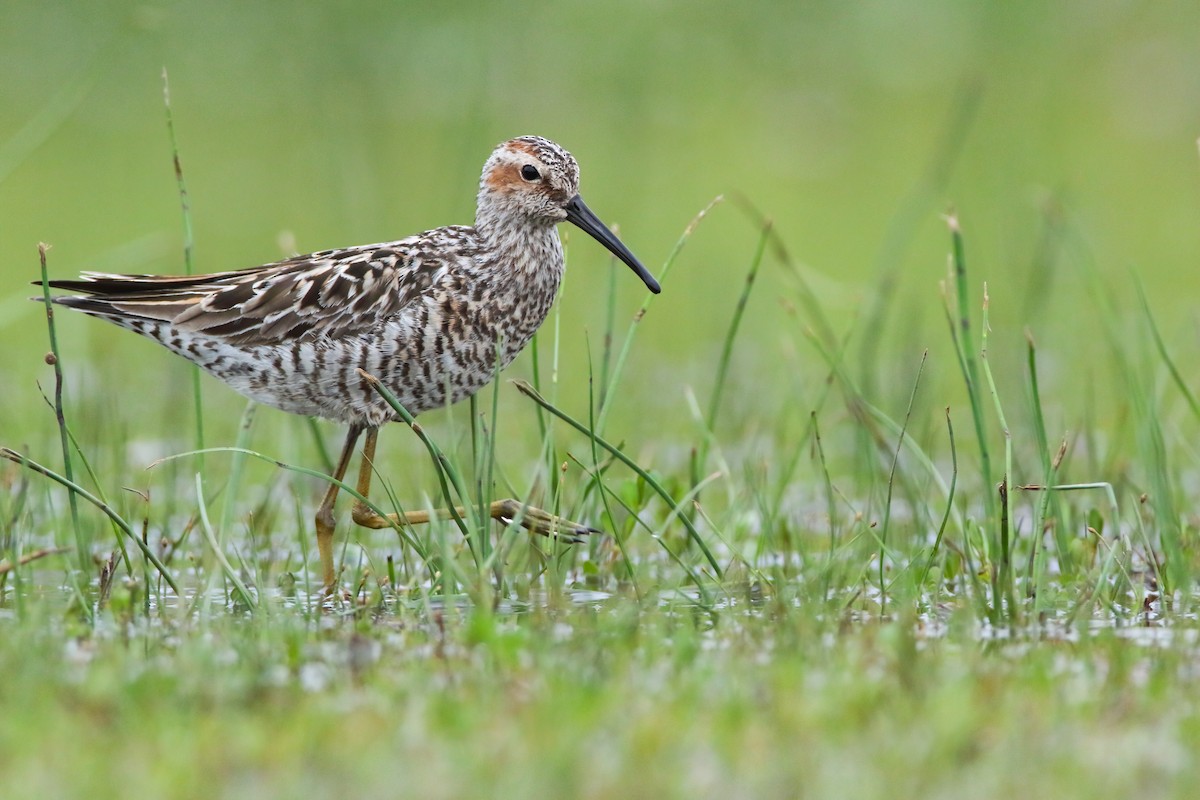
(50, 225, 562, 425)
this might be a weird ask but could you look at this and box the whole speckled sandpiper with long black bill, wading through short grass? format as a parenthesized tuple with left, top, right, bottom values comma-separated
(50, 136, 660, 590)
